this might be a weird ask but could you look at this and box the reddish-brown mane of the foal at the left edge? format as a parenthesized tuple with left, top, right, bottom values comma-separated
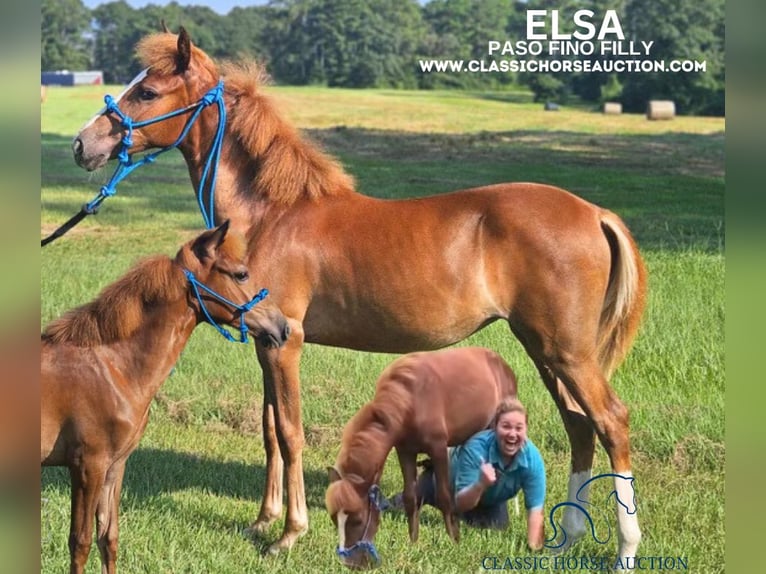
(42, 255, 185, 347)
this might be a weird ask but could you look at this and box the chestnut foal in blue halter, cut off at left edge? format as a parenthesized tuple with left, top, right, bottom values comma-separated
(40, 224, 288, 574)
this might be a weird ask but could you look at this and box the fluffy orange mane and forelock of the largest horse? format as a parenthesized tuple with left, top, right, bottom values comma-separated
(137, 33, 354, 205)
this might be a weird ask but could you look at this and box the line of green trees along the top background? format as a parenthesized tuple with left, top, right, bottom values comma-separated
(41, 0, 725, 115)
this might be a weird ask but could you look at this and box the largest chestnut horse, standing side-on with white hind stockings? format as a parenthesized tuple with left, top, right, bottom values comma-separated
(72, 30, 646, 556)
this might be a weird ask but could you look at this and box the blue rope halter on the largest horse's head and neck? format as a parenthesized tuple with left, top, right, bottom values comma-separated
(83, 80, 226, 229)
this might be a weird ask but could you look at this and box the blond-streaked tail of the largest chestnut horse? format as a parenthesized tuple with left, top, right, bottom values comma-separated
(598, 210, 647, 380)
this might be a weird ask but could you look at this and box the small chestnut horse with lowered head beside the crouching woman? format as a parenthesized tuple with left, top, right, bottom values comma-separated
(325, 347, 516, 567)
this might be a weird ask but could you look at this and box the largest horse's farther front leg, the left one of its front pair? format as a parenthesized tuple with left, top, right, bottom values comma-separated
(249, 364, 283, 533)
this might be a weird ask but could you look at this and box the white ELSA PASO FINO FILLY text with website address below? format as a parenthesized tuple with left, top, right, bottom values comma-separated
(418, 10, 707, 74)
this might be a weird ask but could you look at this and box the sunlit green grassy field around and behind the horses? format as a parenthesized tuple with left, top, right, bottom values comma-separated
(41, 87, 725, 573)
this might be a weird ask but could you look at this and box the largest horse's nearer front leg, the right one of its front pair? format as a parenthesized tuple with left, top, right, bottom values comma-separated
(257, 321, 309, 554)
